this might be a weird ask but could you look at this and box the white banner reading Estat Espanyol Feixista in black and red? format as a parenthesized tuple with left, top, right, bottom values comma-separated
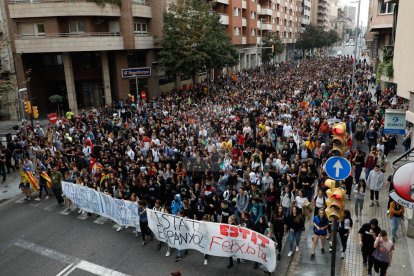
(147, 209, 276, 272)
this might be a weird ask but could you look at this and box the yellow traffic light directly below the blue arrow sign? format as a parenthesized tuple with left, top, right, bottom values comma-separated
(325, 179, 345, 220)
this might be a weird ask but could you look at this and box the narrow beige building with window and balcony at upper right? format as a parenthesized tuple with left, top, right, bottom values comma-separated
(365, 0, 395, 69)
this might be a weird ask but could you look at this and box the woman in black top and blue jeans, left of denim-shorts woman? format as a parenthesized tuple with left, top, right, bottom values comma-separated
(286, 206, 305, 257)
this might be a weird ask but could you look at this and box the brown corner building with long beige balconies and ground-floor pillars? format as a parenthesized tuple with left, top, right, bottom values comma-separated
(6, 0, 171, 115)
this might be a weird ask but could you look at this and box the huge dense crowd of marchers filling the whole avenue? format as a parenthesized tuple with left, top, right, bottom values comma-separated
(0, 56, 411, 275)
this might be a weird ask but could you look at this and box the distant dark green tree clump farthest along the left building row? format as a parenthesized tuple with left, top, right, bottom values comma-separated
(296, 25, 339, 50)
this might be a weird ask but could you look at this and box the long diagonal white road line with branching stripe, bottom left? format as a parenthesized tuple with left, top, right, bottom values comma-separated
(14, 240, 128, 276)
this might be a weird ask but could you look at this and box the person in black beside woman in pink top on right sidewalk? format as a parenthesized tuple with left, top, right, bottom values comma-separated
(358, 218, 381, 275)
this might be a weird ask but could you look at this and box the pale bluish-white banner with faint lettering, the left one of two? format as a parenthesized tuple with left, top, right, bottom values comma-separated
(62, 181, 141, 231)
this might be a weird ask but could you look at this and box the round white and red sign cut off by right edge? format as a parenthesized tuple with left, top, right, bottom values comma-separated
(390, 162, 414, 209)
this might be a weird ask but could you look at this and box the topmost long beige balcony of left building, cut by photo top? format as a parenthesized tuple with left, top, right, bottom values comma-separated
(9, 0, 121, 18)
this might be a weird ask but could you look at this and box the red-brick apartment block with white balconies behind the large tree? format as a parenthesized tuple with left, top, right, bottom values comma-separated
(213, 0, 302, 66)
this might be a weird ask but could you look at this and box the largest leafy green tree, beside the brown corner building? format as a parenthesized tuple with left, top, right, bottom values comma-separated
(160, 0, 238, 82)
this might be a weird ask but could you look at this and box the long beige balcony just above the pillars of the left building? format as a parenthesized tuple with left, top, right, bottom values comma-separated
(15, 33, 124, 53)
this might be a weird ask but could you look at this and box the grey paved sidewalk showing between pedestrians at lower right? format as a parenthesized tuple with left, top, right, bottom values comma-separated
(287, 139, 414, 276)
